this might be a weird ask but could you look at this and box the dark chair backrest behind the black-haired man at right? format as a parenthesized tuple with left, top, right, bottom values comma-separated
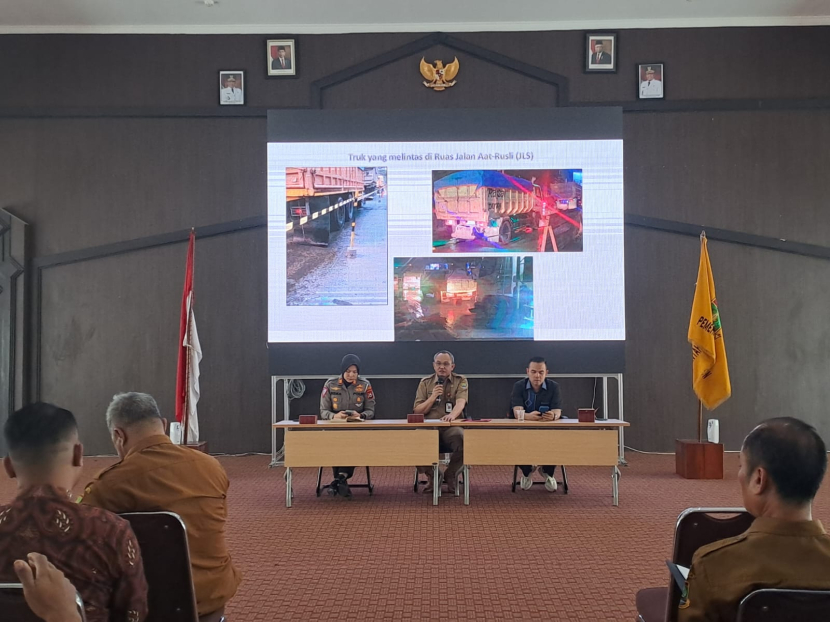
(666, 508, 755, 622)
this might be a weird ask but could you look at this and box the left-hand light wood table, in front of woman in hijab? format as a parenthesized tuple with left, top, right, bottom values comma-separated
(273, 419, 451, 508)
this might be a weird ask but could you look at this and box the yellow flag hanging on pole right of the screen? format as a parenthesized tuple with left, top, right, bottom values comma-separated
(689, 234, 732, 410)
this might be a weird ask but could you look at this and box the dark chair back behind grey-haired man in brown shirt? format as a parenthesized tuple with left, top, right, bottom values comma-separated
(120, 512, 199, 622)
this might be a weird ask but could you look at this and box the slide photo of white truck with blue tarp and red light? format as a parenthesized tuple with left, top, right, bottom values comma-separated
(432, 169, 582, 253)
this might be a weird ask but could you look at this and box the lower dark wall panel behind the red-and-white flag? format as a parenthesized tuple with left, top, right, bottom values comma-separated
(41, 230, 270, 454)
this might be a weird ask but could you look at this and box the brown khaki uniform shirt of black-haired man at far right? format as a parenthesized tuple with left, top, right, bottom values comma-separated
(678, 518, 830, 622)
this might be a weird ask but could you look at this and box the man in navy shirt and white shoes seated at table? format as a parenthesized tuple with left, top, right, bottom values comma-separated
(509, 356, 562, 492)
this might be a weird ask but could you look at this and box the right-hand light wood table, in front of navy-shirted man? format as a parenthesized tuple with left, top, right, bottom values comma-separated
(451, 419, 628, 506)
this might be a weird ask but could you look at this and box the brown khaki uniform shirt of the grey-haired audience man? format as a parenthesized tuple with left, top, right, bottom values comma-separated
(81, 434, 242, 615)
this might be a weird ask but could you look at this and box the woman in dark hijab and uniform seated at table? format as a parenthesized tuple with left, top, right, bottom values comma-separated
(320, 354, 375, 497)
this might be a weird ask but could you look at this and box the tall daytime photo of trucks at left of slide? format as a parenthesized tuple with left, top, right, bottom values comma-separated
(285, 166, 388, 306)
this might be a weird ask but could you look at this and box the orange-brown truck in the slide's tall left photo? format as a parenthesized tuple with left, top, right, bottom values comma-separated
(285, 166, 365, 231)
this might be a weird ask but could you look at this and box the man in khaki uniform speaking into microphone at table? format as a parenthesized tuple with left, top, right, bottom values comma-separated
(414, 350, 468, 493)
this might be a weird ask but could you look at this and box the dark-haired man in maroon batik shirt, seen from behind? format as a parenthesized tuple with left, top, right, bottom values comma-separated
(0, 403, 147, 622)
